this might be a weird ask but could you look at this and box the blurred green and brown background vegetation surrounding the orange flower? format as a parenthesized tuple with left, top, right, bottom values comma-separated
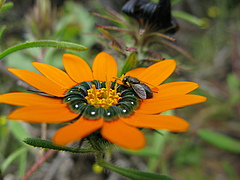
(0, 0, 240, 180)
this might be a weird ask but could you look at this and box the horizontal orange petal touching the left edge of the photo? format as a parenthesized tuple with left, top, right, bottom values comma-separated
(0, 92, 62, 106)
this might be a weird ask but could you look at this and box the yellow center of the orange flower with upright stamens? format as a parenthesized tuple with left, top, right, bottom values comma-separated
(85, 82, 121, 109)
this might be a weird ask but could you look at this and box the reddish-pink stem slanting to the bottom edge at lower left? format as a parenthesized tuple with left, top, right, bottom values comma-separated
(20, 150, 57, 180)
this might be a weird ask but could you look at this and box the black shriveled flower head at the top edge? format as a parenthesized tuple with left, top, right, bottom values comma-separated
(122, 0, 179, 34)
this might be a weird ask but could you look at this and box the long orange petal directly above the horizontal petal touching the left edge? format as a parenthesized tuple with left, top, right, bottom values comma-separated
(8, 68, 67, 97)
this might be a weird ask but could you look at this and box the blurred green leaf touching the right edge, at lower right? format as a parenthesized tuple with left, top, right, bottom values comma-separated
(198, 129, 240, 153)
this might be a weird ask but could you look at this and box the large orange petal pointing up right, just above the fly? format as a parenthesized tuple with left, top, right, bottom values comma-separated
(136, 59, 176, 86)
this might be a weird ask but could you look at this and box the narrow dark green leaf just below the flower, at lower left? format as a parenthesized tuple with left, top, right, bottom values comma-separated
(23, 138, 97, 153)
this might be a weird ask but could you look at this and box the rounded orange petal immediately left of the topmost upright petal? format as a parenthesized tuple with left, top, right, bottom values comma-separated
(63, 53, 93, 83)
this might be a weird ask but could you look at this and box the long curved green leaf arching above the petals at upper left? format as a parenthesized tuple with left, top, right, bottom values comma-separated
(0, 40, 87, 59)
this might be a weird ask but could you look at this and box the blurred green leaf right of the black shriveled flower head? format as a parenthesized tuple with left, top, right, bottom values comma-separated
(172, 10, 204, 27)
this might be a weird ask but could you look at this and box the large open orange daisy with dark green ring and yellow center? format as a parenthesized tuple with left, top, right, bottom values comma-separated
(0, 52, 206, 150)
